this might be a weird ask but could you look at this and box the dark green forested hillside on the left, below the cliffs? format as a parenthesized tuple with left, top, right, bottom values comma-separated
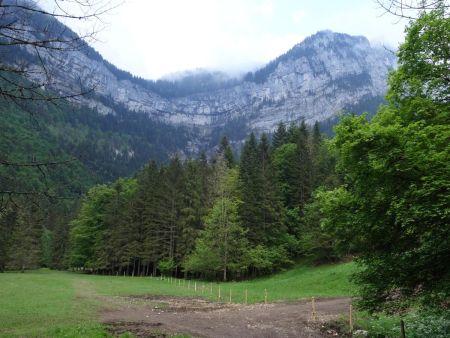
(0, 96, 192, 271)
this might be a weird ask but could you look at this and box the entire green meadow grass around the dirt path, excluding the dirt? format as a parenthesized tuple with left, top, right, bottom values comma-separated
(0, 263, 356, 337)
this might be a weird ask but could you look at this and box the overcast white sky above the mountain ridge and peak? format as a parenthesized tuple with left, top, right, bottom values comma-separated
(44, 0, 407, 79)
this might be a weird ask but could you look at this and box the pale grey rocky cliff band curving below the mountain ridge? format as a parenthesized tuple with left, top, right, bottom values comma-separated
(21, 27, 395, 139)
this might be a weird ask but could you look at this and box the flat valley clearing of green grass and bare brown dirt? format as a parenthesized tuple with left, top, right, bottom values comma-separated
(0, 263, 356, 337)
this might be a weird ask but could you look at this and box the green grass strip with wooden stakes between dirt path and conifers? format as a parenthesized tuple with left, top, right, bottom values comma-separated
(79, 263, 356, 303)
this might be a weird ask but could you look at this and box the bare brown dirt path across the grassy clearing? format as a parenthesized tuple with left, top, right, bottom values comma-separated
(101, 296, 350, 338)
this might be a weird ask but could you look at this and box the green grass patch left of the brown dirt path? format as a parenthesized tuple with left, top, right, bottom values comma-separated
(0, 270, 104, 337)
